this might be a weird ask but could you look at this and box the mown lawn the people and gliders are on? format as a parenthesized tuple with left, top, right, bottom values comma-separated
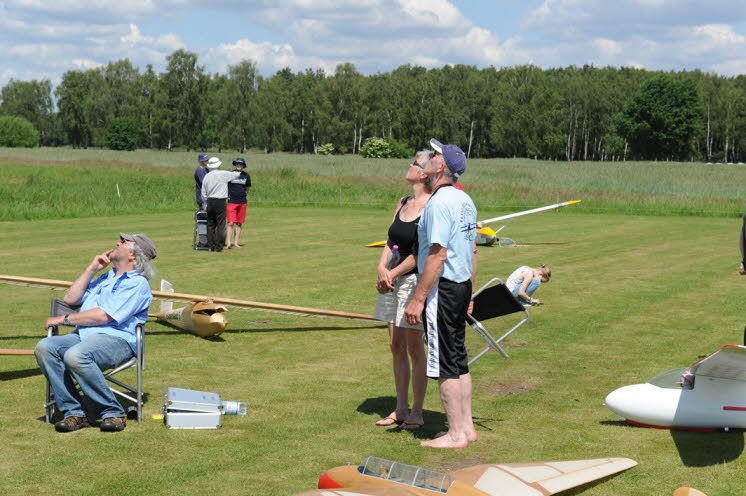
(0, 151, 746, 496)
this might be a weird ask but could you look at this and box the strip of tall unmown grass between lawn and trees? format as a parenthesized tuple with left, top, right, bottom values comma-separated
(0, 148, 746, 221)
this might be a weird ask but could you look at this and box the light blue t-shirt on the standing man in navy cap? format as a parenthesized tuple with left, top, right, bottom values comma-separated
(417, 186, 477, 282)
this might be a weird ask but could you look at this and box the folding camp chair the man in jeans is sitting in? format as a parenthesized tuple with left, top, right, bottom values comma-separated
(44, 298, 145, 423)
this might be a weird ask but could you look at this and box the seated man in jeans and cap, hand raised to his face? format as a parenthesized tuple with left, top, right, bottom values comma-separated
(34, 233, 156, 432)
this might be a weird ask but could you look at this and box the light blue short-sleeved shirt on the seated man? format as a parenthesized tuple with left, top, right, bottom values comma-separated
(76, 268, 153, 353)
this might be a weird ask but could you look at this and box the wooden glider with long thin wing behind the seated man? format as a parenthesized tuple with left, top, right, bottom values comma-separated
(0, 275, 379, 355)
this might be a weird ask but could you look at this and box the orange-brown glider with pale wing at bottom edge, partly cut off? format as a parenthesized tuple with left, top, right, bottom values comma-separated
(296, 456, 637, 496)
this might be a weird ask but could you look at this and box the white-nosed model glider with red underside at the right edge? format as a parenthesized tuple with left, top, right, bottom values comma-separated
(605, 344, 746, 431)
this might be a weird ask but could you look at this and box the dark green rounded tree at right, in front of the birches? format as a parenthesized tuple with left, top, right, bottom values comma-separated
(617, 74, 701, 159)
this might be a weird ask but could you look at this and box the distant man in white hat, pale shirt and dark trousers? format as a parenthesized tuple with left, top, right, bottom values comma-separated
(202, 157, 241, 252)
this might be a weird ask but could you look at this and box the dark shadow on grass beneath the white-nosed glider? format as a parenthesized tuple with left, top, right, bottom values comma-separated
(671, 429, 743, 467)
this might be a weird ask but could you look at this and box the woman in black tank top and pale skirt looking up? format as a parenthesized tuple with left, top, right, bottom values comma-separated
(375, 150, 431, 430)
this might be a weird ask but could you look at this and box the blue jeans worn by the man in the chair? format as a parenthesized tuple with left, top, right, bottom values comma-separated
(34, 332, 134, 420)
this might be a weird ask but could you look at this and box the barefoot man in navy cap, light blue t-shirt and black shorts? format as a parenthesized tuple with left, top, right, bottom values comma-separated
(405, 139, 477, 448)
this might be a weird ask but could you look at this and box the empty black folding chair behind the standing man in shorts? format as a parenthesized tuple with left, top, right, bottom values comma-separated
(466, 277, 529, 365)
